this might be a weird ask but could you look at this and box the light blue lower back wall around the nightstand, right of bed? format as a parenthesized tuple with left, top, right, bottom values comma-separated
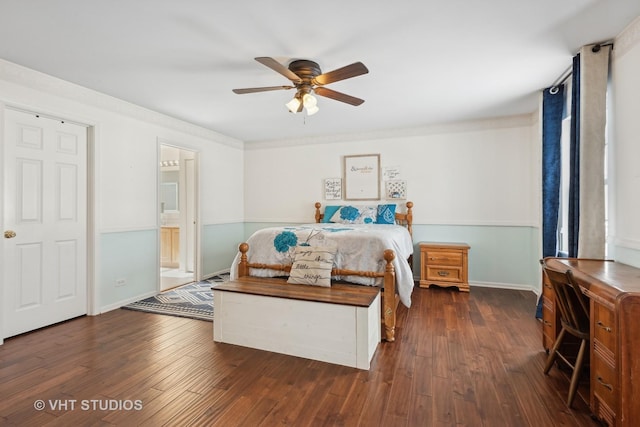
(413, 224, 540, 294)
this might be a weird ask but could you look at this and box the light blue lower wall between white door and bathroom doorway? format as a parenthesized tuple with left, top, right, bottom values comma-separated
(97, 229, 159, 311)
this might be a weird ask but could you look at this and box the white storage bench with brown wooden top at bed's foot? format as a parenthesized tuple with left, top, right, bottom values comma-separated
(212, 276, 381, 369)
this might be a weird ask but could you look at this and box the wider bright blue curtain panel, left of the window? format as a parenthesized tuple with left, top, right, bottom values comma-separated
(536, 85, 564, 319)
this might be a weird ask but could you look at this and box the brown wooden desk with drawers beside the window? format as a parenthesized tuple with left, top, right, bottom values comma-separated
(543, 258, 640, 426)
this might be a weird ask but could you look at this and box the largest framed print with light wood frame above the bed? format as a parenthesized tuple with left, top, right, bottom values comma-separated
(344, 154, 380, 200)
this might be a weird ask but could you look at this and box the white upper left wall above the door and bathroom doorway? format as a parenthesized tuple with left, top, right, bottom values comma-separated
(0, 60, 244, 232)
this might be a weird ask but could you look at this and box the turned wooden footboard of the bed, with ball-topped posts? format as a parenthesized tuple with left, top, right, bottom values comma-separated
(238, 243, 399, 342)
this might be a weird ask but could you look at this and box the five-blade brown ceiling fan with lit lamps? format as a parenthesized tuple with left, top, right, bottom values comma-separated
(233, 56, 369, 115)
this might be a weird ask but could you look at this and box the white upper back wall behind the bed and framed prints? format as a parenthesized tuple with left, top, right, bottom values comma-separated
(245, 115, 540, 227)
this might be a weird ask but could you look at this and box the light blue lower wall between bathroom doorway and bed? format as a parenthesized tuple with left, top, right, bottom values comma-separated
(201, 222, 246, 278)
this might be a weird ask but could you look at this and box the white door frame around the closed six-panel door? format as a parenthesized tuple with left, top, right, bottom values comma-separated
(0, 103, 99, 345)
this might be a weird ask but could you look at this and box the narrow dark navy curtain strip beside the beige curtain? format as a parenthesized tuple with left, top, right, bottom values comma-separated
(563, 55, 580, 257)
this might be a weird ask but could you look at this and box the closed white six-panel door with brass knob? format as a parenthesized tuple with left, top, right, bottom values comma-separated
(2, 109, 87, 338)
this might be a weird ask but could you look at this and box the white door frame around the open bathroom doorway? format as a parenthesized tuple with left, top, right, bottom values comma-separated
(156, 138, 202, 291)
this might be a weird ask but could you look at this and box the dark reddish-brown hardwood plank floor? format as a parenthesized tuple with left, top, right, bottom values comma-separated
(0, 287, 597, 426)
